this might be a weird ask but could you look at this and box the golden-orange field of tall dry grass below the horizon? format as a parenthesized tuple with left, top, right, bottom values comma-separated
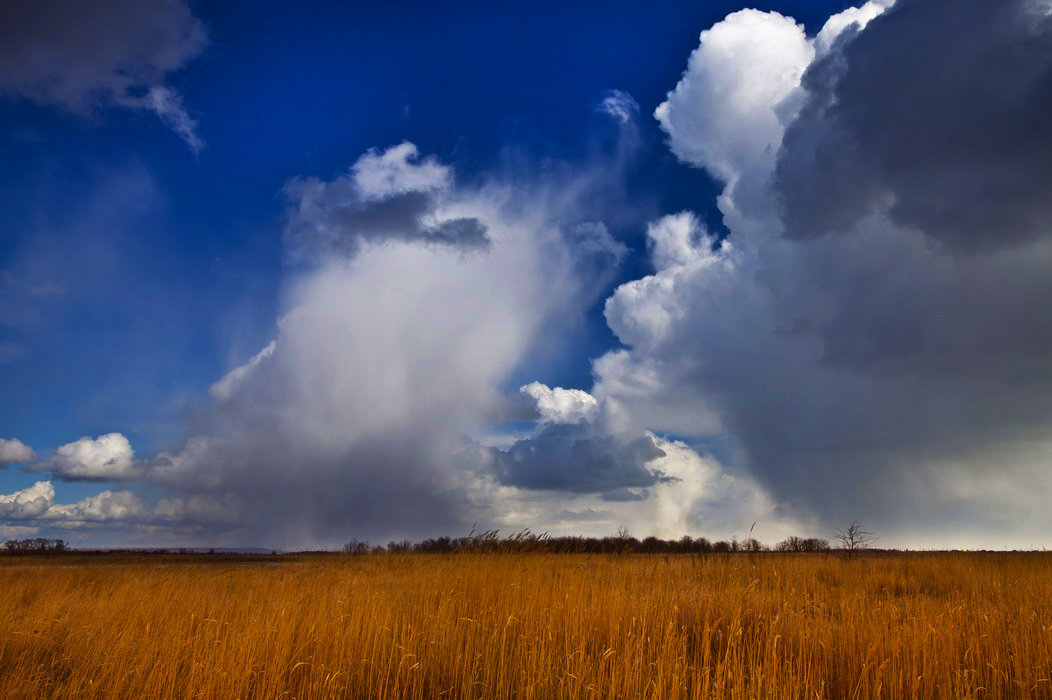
(0, 554, 1052, 698)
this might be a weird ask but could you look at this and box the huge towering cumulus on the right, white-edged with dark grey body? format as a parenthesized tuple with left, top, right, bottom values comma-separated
(595, 0, 1052, 545)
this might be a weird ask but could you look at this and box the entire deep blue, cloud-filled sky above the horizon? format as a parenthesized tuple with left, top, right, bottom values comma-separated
(0, 0, 1052, 548)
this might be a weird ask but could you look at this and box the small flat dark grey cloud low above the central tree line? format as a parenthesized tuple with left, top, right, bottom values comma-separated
(493, 424, 665, 500)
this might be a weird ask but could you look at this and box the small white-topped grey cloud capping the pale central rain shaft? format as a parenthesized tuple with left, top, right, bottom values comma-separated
(284, 142, 490, 258)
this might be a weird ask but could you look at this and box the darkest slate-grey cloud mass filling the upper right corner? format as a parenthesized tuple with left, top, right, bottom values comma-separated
(774, 0, 1052, 252)
